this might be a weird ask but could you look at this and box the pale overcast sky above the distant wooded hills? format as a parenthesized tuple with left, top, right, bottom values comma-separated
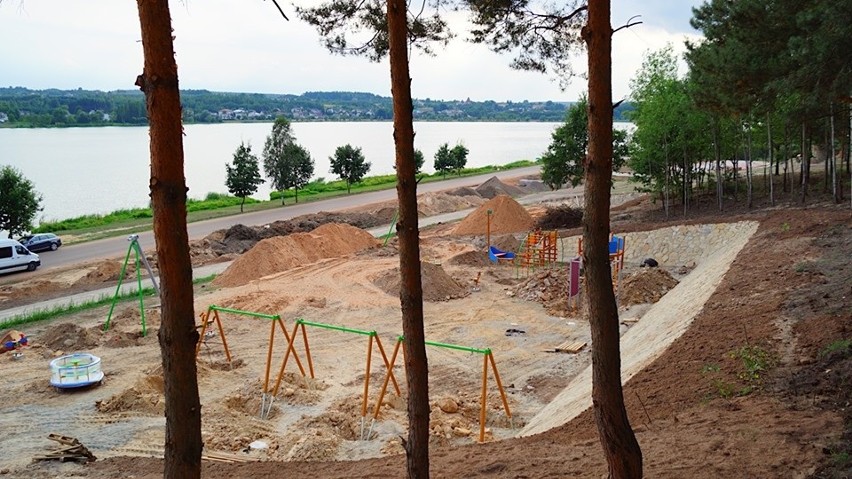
(0, 0, 701, 101)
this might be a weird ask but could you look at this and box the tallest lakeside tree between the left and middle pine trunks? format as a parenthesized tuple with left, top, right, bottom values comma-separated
(263, 116, 314, 205)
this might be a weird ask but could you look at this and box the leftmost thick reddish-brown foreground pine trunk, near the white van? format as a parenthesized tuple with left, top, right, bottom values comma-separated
(136, 0, 202, 479)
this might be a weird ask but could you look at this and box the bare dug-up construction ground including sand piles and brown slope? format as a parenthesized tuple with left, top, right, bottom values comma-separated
(0, 176, 852, 478)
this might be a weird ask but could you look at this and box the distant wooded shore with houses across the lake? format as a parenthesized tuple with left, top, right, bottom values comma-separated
(0, 87, 632, 128)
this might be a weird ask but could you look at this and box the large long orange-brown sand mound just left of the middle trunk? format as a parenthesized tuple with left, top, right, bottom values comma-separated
(213, 223, 379, 287)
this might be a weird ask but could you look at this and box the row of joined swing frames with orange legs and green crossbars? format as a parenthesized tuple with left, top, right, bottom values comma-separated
(193, 305, 514, 442)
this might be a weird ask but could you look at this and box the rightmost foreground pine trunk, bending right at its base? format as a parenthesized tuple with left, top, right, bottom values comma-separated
(583, 0, 642, 478)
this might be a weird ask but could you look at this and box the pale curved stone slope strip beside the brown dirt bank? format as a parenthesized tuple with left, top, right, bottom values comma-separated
(520, 222, 758, 436)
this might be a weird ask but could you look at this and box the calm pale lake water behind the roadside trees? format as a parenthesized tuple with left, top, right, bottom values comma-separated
(0, 122, 558, 220)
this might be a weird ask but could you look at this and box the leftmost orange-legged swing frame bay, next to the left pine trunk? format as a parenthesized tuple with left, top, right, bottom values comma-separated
(195, 305, 306, 419)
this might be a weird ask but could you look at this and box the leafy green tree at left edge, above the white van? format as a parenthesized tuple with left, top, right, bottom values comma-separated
(0, 166, 42, 238)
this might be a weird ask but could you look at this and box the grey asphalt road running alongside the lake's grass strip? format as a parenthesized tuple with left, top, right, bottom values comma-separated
(20, 166, 541, 274)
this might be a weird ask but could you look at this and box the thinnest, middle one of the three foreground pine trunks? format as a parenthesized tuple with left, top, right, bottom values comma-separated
(388, 0, 430, 479)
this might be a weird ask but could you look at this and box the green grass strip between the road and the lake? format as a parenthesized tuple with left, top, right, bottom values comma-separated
(33, 160, 536, 244)
